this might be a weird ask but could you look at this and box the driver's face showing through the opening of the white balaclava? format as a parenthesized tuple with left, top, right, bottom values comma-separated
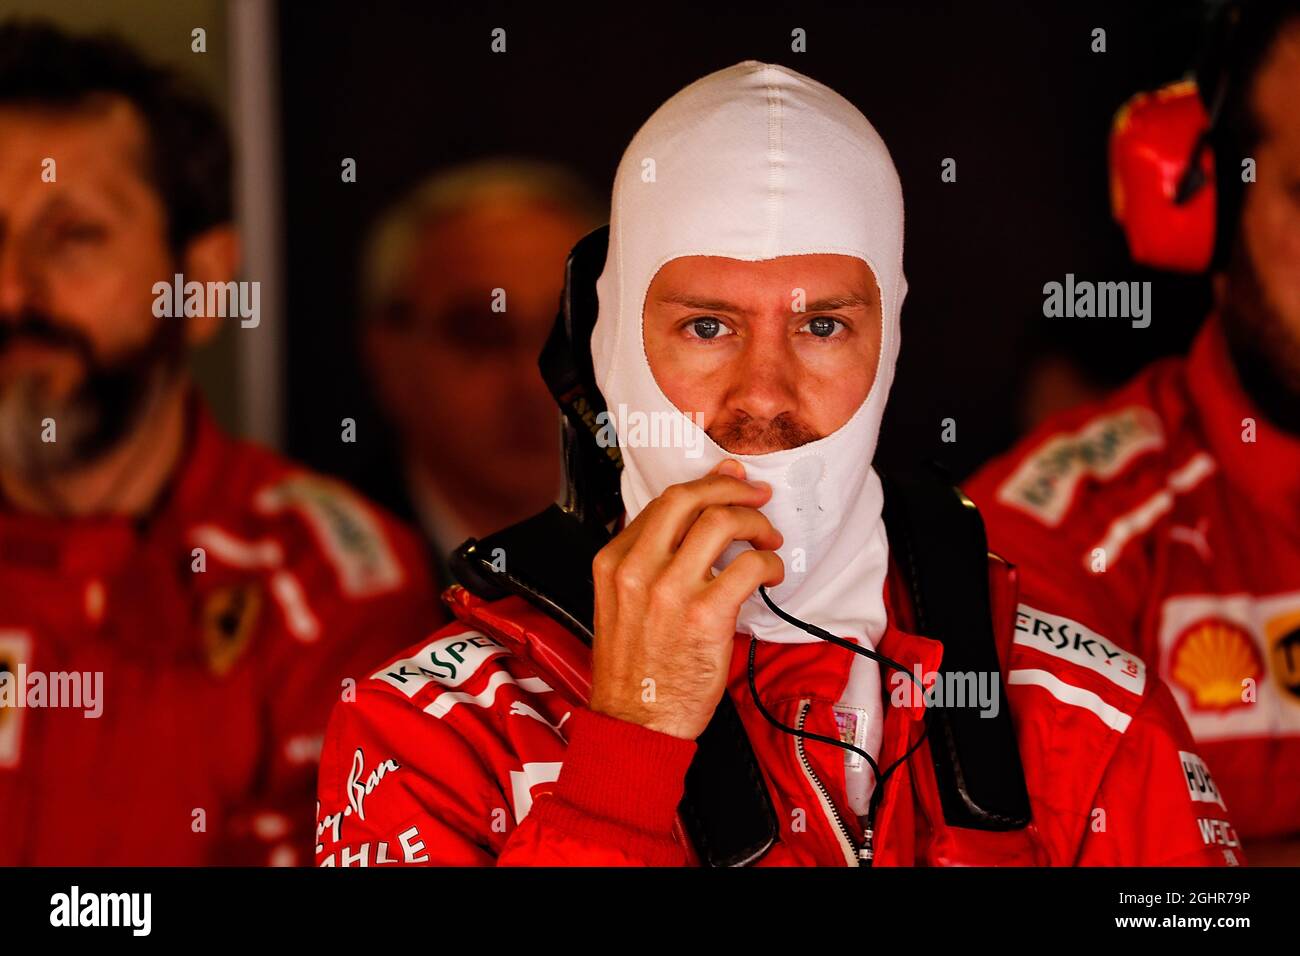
(644, 255, 880, 455)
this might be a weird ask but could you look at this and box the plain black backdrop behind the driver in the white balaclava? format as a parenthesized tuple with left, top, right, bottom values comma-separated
(280, 1, 1209, 477)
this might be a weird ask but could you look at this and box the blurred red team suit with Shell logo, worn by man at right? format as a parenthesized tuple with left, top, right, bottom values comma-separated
(965, 317, 1300, 838)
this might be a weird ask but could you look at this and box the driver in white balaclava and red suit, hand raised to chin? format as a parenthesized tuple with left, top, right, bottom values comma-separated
(317, 61, 1231, 866)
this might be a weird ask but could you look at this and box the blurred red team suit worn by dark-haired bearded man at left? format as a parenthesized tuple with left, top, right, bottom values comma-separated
(0, 397, 445, 866)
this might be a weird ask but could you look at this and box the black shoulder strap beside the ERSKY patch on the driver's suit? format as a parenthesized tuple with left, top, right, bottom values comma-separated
(881, 466, 1031, 830)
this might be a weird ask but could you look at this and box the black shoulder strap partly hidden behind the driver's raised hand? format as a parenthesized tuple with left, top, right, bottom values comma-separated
(451, 505, 777, 866)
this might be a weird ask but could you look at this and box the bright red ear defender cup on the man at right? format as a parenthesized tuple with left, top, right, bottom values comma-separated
(1110, 79, 1214, 272)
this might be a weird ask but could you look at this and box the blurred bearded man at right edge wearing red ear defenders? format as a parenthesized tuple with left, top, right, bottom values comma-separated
(966, 0, 1300, 864)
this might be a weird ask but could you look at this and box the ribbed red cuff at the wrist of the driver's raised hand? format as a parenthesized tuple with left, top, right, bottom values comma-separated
(538, 708, 696, 840)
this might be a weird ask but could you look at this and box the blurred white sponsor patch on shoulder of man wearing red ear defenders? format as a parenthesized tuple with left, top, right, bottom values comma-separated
(997, 406, 1165, 528)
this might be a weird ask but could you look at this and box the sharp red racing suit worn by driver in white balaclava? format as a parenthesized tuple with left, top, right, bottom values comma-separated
(316, 546, 1242, 866)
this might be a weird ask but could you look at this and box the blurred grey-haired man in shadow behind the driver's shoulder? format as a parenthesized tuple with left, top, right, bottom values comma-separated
(359, 160, 605, 585)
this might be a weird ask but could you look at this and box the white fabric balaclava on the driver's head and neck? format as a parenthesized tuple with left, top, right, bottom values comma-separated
(592, 60, 907, 658)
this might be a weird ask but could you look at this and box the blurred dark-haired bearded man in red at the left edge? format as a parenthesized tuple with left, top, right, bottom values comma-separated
(0, 23, 437, 865)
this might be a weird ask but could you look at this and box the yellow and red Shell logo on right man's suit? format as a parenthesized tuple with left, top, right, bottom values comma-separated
(1170, 618, 1264, 710)
